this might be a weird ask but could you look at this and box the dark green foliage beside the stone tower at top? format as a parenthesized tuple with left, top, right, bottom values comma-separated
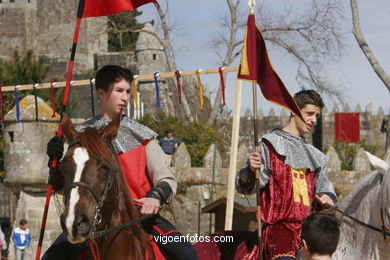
(108, 10, 143, 51)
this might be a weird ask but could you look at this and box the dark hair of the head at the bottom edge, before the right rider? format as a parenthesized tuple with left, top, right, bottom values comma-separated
(301, 214, 340, 256)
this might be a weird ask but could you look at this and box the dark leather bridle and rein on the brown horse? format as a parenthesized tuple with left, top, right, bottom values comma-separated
(64, 140, 153, 240)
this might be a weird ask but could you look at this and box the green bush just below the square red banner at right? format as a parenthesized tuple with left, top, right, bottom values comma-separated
(333, 140, 378, 171)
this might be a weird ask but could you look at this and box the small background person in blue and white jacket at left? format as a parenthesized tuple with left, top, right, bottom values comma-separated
(11, 219, 31, 260)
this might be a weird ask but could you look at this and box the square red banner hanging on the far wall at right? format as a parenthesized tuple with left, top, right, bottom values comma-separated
(334, 113, 360, 143)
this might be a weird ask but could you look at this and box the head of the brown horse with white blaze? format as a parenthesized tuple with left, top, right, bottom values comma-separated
(59, 114, 120, 243)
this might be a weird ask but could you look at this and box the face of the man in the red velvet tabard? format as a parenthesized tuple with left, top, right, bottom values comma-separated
(294, 104, 321, 136)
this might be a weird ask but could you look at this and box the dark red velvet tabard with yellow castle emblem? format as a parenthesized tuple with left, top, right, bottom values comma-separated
(260, 140, 316, 259)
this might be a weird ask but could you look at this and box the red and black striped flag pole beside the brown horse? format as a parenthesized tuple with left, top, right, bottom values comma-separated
(35, 0, 84, 260)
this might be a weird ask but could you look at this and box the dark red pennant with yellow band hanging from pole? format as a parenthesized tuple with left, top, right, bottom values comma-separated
(238, 14, 303, 120)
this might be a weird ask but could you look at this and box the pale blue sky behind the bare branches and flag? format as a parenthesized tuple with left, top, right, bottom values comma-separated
(138, 0, 390, 114)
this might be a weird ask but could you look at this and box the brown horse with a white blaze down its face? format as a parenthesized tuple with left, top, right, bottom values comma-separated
(59, 115, 155, 260)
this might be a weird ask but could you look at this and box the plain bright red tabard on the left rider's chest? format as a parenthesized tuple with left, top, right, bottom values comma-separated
(117, 144, 152, 199)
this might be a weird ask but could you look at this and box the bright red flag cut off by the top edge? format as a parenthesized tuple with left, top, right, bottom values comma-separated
(78, 0, 157, 18)
